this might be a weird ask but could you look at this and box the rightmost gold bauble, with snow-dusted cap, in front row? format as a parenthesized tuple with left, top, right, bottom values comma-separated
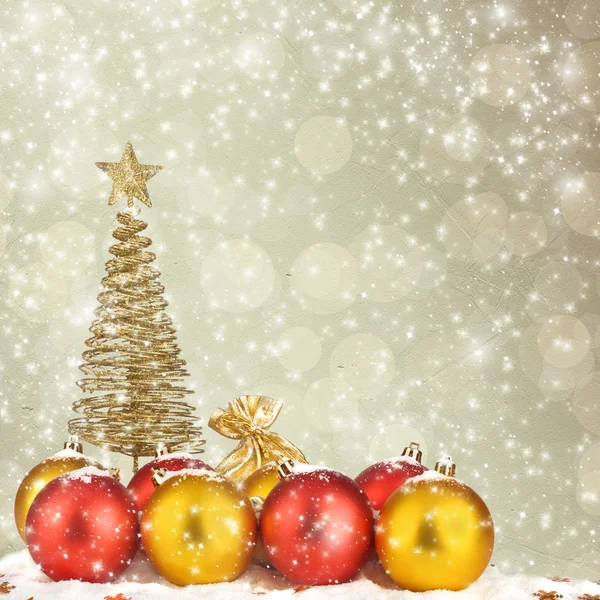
(375, 456, 494, 592)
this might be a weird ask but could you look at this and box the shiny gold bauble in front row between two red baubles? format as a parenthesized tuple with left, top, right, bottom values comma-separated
(141, 469, 256, 585)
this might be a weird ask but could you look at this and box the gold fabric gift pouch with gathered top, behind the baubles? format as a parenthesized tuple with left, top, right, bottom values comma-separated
(208, 396, 306, 482)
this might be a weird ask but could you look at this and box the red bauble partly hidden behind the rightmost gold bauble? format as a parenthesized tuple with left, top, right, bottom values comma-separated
(355, 442, 427, 510)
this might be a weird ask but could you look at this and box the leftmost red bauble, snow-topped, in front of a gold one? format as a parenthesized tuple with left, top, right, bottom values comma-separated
(26, 467, 138, 583)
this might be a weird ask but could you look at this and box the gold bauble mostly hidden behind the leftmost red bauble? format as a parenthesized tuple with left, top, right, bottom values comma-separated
(15, 435, 102, 542)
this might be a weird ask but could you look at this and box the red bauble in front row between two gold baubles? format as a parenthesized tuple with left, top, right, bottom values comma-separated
(260, 465, 373, 585)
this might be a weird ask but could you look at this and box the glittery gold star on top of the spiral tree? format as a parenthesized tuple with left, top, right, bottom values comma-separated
(96, 142, 162, 207)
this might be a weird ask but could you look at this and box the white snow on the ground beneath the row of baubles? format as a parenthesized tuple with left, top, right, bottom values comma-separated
(0, 550, 600, 600)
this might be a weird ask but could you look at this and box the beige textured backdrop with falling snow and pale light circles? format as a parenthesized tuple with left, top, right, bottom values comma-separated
(0, 0, 600, 579)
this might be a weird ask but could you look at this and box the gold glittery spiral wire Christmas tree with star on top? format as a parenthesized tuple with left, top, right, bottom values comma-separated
(69, 143, 204, 471)
